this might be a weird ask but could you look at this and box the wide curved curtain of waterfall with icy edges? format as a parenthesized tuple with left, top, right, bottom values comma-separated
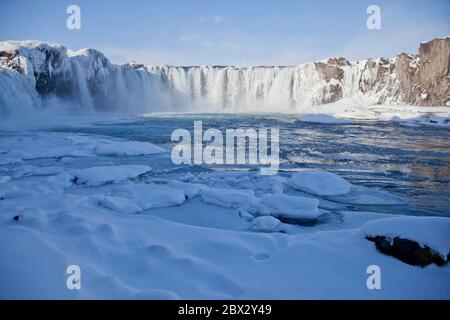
(0, 41, 426, 113)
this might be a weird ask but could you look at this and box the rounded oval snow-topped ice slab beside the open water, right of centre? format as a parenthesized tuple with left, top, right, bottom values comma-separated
(289, 169, 351, 196)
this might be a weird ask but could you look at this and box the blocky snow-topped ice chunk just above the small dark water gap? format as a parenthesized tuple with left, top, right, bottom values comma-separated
(260, 194, 319, 219)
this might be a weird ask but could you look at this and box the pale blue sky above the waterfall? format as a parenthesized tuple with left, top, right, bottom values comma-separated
(0, 0, 450, 65)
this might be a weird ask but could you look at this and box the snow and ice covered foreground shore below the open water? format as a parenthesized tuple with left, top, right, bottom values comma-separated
(0, 131, 450, 299)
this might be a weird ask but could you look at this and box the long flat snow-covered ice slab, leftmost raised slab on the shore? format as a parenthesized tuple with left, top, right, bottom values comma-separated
(72, 165, 152, 186)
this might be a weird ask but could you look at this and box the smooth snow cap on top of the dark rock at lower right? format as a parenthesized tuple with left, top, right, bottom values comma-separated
(361, 217, 450, 257)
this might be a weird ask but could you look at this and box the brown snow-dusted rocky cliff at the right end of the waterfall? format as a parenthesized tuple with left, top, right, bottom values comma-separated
(315, 37, 450, 106)
